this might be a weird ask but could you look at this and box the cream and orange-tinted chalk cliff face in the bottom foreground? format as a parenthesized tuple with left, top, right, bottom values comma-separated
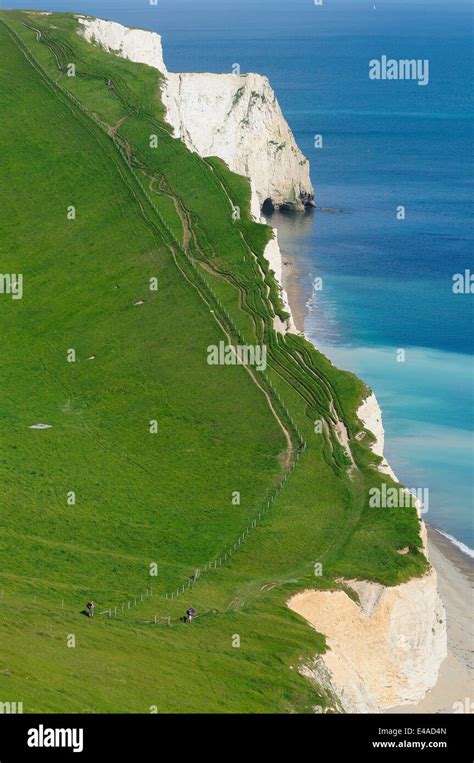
(288, 569, 447, 713)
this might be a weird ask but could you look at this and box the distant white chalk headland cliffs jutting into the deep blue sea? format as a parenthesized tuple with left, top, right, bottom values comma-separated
(78, 17, 314, 214)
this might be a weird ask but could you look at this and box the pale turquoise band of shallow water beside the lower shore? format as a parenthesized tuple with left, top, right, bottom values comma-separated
(309, 344, 474, 555)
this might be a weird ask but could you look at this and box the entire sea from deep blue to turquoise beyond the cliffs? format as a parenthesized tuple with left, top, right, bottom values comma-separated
(8, 0, 474, 549)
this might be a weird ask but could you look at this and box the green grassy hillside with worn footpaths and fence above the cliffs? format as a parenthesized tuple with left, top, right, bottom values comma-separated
(0, 11, 426, 713)
